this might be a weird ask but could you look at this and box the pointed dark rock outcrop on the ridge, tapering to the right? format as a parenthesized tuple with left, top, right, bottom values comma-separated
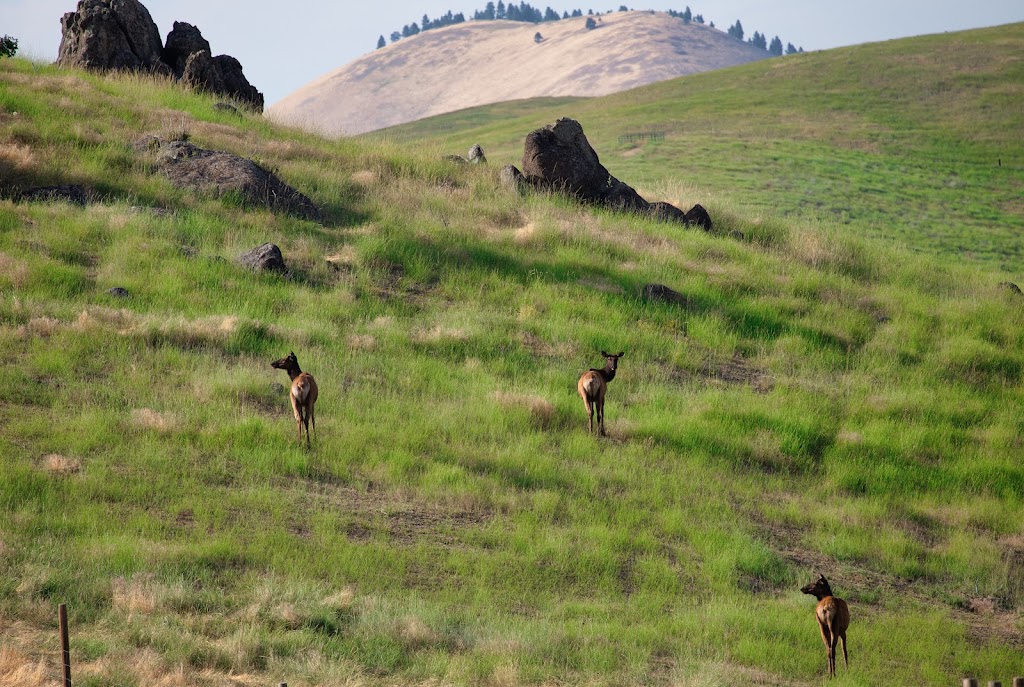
(509, 118, 712, 230)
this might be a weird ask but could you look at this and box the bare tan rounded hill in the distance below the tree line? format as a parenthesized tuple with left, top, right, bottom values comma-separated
(267, 12, 767, 135)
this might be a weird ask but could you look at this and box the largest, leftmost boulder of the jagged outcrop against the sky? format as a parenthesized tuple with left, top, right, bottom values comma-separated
(57, 0, 169, 74)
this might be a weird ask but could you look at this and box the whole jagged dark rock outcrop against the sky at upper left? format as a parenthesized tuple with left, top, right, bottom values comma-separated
(57, 0, 263, 112)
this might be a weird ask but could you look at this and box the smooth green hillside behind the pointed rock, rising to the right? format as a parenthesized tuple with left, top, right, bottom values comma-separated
(380, 24, 1024, 275)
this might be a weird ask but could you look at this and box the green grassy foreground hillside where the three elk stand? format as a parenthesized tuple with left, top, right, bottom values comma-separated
(0, 53, 1024, 687)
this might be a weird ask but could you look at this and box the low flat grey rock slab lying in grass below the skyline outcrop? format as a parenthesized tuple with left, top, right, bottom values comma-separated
(150, 141, 321, 221)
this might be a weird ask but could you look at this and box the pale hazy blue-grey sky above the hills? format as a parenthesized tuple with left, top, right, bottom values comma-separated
(0, 0, 1024, 105)
